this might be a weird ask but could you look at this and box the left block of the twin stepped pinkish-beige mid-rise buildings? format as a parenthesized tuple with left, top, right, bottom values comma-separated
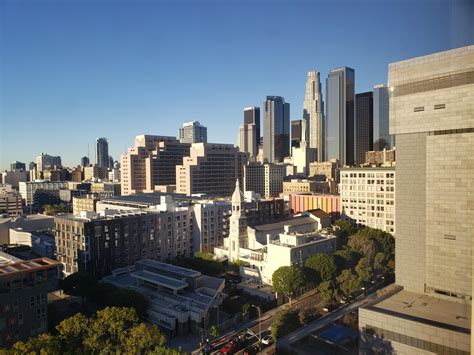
(120, 135, 191, 195)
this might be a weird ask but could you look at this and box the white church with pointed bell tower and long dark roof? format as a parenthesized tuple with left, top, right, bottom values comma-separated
(214, 180, 337, 285)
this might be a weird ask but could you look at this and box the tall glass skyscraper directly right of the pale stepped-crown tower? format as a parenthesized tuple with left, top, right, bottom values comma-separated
(325, 67, 355, 166)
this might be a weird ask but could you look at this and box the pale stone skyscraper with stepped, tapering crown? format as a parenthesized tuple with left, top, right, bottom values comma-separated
(303, 71, 324, 161)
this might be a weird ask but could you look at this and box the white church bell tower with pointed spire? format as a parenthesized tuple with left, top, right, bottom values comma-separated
(228, 179, 248, 262)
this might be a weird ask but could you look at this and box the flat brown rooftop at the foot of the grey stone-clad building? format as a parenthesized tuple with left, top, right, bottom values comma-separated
(364, 290, 471, 334)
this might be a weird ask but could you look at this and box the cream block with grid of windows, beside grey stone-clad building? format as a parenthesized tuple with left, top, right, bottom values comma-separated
(339, 167, 395, 235)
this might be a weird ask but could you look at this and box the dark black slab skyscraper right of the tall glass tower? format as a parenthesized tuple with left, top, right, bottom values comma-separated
(355, 91, 374, 164)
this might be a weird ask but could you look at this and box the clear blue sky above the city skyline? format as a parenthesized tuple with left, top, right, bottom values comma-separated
(0, 0, 474, 168)
